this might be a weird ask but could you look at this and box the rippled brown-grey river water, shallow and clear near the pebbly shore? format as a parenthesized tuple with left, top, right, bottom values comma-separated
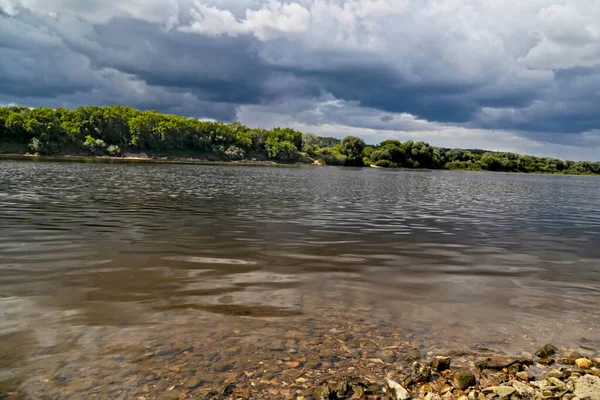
(0, 162, 600, 398)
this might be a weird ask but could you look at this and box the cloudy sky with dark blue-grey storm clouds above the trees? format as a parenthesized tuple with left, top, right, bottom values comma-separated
(0, 0, 600, 161)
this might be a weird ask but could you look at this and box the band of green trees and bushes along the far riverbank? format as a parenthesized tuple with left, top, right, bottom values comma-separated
(0, 106, 600, 175)
